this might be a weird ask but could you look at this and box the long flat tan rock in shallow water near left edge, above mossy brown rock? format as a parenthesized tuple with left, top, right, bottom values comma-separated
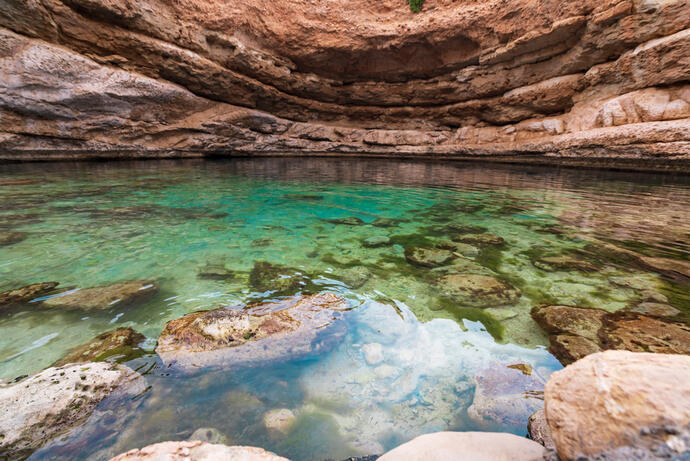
(41, 280, 158, 310)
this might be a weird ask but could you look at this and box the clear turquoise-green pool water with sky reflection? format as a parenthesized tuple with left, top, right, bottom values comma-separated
(0, 159, 690, 460)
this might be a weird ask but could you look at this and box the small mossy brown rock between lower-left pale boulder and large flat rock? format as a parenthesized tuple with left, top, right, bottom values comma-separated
(52, 328, 146, 367)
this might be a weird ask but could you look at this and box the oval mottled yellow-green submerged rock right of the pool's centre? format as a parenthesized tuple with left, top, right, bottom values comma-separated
(438, 274, 521, 307)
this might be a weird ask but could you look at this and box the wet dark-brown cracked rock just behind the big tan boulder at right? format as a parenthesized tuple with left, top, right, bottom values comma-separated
(531, 304, 690, 365)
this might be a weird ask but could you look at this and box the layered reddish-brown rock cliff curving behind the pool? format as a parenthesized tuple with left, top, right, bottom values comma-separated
(0, 0, 690, 171)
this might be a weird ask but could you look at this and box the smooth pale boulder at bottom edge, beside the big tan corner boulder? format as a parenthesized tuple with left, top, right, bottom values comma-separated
(379, 432, 544, 461)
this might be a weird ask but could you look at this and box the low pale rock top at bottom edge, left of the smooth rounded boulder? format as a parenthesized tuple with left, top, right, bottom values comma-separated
(110, 440, 289, 461)
